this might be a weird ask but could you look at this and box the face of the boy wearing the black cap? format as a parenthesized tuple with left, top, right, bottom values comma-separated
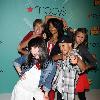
(59, 43, 72, 55)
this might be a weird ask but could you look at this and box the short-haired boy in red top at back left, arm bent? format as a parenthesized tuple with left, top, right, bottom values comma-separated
(18, 19, 44, 55)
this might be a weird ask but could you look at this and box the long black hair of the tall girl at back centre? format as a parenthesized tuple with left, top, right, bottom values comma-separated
(44, 18, 64, 40)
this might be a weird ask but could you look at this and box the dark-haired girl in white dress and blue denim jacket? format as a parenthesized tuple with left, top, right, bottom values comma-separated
(11, 37, 54, 100)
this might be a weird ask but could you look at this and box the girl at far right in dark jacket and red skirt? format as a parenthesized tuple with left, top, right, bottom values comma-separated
(73, 28, 96, 100)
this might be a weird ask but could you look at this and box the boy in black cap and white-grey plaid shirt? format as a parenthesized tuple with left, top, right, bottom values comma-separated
(52, 36, 85, 100)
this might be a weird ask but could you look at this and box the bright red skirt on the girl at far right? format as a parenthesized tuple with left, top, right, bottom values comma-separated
(76, 74, 90, 92)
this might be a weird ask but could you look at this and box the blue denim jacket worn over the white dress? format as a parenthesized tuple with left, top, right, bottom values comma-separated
(14, 56, 56, 92)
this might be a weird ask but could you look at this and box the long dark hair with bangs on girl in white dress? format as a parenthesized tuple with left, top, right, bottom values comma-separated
(27, 37, 48, 68)
